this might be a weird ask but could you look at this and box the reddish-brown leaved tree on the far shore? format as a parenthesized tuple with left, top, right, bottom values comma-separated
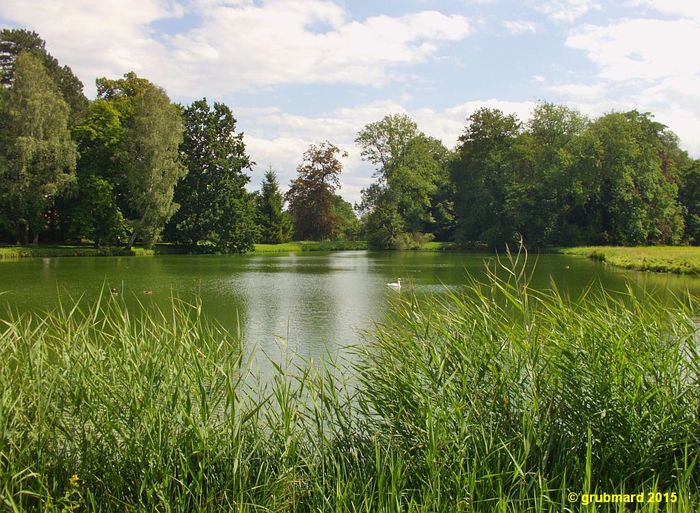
(285, 141, 347, 240)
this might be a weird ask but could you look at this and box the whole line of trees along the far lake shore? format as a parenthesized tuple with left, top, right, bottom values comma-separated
(0, 29, 700, 252)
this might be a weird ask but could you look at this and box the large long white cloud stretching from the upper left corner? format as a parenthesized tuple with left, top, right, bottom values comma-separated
(0, 0, 471, 97)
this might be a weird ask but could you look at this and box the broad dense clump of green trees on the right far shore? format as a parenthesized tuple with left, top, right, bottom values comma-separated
(452, 103, 690, 247)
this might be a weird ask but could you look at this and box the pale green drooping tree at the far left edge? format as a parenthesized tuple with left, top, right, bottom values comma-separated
(0, 52, 76, 243)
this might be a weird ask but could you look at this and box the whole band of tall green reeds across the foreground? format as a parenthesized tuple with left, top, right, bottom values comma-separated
(0, 260, 700, 513)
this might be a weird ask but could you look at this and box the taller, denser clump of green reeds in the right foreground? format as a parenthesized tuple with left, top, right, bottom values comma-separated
(358, 248, 700, 511)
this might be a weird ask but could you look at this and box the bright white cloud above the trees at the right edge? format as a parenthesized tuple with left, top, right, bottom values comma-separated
(550, 12, 700, 157)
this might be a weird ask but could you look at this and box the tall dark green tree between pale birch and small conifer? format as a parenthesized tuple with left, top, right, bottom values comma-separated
(169, 98, 256, 252)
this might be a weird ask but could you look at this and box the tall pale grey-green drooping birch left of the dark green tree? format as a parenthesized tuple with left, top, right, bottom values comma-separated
(97, 73, 187, 248)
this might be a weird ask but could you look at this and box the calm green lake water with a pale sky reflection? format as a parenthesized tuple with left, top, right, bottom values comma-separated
(0, 251, 700, 366)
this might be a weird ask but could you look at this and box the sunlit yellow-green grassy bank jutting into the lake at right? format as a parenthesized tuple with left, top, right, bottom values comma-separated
(559, 246, 700, 274)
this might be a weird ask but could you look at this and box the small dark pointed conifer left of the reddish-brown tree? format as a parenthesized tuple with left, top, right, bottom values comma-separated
(257, 168, 293, 244)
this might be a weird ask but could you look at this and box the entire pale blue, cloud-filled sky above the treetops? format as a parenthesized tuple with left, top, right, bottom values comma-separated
(0, 0, 700, 202)
